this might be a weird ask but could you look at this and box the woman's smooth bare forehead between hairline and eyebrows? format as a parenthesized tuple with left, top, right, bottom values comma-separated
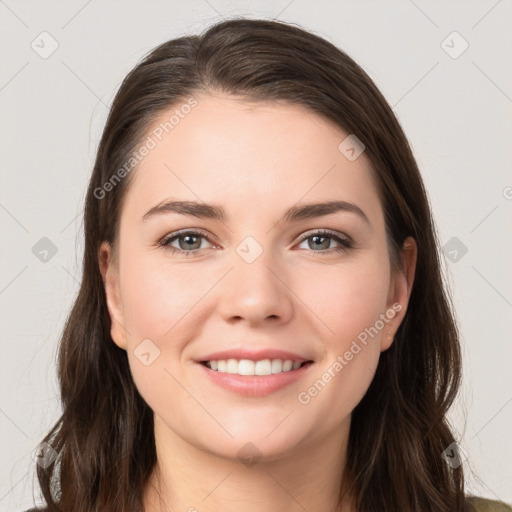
(123, 95, 381, 226)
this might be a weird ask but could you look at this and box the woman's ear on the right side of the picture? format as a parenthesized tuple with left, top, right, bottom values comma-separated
(380, 237, 418, 352)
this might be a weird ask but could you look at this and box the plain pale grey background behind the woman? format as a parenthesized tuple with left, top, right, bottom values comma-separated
(0, 0, 512, 512)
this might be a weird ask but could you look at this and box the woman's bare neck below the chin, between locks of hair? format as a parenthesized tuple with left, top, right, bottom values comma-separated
(144, 415, 355, 512)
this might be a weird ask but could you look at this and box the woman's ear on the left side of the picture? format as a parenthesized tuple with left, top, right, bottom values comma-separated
(98, 242, 127, 350)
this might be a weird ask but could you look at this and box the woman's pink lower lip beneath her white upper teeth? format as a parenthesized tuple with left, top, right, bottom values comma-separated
(197, 362, 313, 396)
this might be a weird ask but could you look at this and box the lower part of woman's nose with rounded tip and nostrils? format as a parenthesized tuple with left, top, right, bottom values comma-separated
(218, 252, 294, 326)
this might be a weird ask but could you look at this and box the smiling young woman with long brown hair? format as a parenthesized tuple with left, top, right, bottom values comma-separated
(27, 19, 512, 512)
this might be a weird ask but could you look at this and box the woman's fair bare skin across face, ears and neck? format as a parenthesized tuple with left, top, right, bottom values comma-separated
(99, 95, 417, 512)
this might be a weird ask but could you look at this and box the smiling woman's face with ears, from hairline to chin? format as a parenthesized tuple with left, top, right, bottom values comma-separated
(100, 96, 415, 460)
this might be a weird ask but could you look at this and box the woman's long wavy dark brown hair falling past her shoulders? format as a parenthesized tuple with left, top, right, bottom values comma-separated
(37, 18, 464, 512)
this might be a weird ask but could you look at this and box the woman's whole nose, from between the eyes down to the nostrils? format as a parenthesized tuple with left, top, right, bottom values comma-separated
(219, 236, 292, 323)
